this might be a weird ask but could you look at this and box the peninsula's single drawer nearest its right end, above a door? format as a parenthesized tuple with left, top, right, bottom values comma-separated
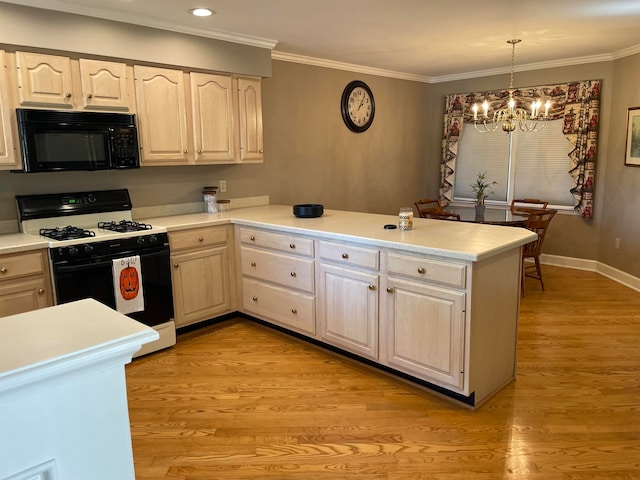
(388, 253, 467, 288)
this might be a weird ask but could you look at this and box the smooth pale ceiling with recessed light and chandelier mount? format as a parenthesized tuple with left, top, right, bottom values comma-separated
(4, 0, 640, 82)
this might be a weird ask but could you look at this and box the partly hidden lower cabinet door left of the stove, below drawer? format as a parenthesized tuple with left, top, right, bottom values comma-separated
(0, 277, 53, 317)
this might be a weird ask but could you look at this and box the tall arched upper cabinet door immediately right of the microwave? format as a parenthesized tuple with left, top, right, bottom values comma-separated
(134, 65, 190, 165)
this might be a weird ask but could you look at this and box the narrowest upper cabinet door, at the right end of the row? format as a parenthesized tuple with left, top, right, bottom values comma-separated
(238, 78, 264, 162)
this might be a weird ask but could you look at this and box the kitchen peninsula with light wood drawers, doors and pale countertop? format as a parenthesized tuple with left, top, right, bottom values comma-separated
(144, 205, 535, 406)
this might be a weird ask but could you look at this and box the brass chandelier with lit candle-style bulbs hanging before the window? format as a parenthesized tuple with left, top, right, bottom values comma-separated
(471, 39, 551, 133)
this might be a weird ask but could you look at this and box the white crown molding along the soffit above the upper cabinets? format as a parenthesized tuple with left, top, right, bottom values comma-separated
(2, 0, 278, 50)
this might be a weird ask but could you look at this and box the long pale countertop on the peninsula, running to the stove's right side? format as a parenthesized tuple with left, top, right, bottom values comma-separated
(142, 205, 536, 261)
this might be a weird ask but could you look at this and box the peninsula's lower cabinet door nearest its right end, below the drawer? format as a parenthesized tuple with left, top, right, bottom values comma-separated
(382, 278, 465, 389)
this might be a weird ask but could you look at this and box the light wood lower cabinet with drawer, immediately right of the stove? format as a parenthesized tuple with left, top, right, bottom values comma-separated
(169, 226, 232, 327)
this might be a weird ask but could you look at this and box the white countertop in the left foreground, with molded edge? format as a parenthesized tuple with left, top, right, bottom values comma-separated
(0, 299, 158, 394)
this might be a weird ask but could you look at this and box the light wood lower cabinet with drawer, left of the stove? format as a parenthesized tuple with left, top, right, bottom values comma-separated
(0, 250, 53, 317)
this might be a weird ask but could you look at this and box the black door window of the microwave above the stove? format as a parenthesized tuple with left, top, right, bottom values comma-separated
(28, 127, 109, 171)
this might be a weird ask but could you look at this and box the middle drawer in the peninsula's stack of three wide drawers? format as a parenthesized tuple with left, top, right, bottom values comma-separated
(241, 247, 314, 293)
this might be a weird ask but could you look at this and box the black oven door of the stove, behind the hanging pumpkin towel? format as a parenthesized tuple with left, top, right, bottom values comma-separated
(53, 250, 173, 327)
